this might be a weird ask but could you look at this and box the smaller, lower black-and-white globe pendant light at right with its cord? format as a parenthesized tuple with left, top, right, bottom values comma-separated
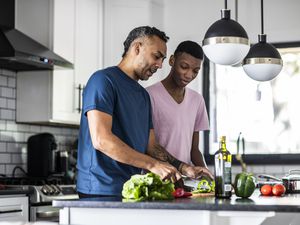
(243, 0, 282, 81)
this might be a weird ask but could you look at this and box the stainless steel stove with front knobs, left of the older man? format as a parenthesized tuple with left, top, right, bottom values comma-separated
(0, 177, 78, 222)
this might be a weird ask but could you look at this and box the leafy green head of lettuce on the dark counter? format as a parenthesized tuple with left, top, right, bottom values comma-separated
(122, 173, 175, 201)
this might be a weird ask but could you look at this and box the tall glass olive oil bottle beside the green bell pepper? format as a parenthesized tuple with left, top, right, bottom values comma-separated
(215, 136, 232, 198)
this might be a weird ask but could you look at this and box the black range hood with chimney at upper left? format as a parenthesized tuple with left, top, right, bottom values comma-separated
(0, 0, 73, 71)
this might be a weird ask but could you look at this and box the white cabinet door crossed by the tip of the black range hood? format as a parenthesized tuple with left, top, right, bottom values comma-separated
(50, 0, 80, 124)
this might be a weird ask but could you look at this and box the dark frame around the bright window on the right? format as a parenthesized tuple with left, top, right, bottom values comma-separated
(202, 41, 300, 165)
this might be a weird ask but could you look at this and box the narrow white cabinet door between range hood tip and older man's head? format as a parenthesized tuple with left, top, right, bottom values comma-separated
(74, 0, 103, 86)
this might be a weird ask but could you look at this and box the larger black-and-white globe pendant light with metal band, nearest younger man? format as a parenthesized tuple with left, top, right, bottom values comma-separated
(202, 0, 250, 65)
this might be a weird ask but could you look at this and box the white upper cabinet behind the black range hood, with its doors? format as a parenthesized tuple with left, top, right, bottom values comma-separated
(16, 0, 103, 125)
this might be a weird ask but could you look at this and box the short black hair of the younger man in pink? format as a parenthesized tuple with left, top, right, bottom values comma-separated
(174, 41, 203, 60)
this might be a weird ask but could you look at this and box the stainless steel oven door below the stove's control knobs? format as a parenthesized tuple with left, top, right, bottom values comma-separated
(30, 205, 59, 222)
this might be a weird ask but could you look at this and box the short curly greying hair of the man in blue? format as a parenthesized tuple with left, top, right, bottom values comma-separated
(122, 26, 169, 57)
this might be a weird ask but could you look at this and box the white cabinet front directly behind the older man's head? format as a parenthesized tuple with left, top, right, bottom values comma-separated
(103, 0, 163, 67)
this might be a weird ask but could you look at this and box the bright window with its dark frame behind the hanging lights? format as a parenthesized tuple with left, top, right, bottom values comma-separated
(203, 43, 300, 164)
